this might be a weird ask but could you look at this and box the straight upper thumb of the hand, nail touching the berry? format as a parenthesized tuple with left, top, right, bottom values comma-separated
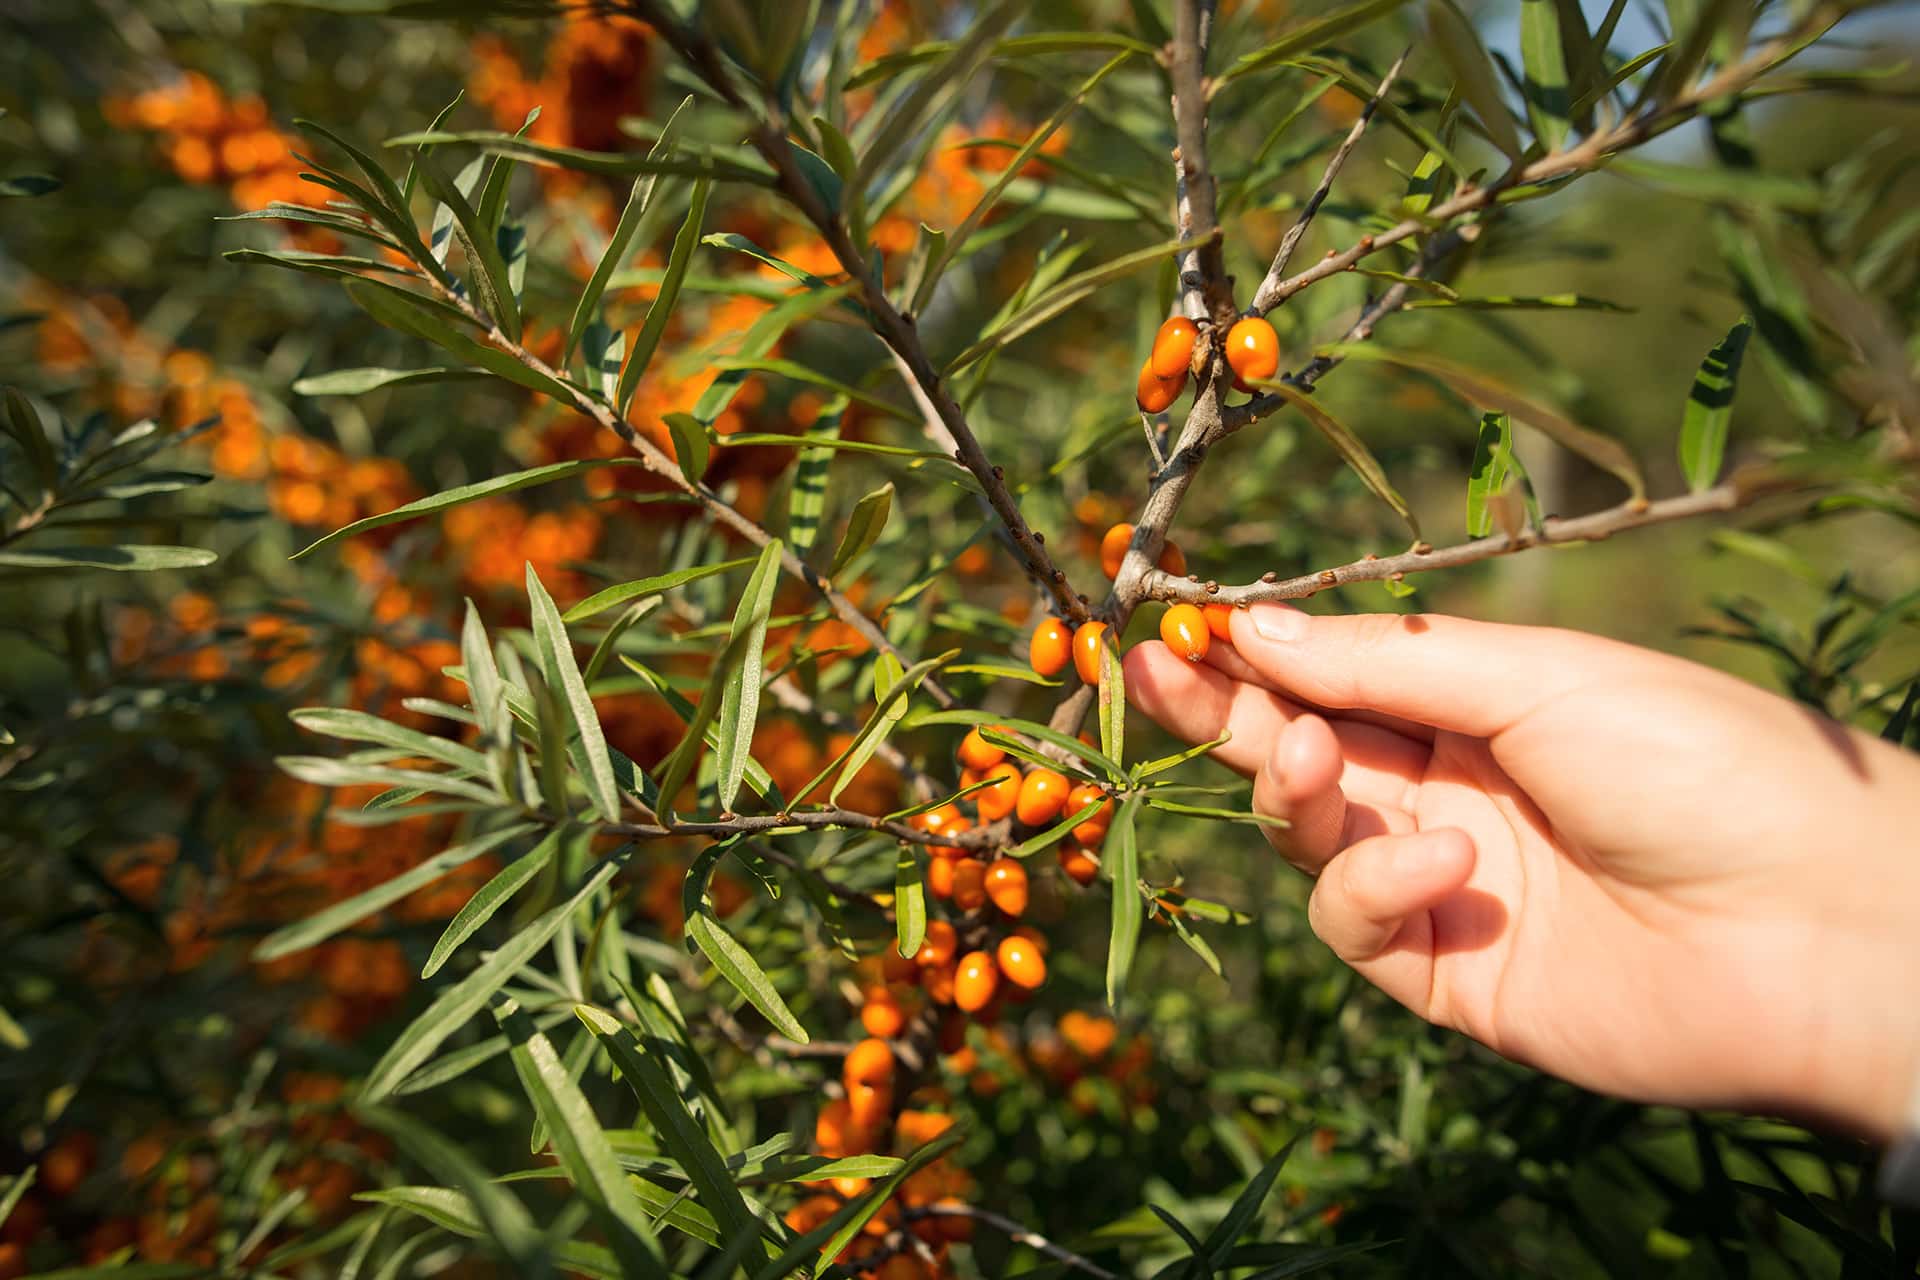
(1233, 604, 1605, 737)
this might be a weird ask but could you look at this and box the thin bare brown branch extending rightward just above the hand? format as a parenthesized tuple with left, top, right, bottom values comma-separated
(1142, 478, 1789, 604)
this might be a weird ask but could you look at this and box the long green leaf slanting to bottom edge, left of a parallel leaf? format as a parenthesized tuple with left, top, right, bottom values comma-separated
(493, 1000, 668, 1278)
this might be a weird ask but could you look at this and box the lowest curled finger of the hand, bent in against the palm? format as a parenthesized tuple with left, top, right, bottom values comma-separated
(1308, 827, 1476, 1015)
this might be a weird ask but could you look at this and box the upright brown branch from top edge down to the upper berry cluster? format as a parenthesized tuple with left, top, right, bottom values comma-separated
(1169, 0, 1233, 328)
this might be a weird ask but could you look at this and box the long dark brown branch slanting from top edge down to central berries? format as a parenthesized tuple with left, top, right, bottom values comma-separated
(628, 0, 1089, 622)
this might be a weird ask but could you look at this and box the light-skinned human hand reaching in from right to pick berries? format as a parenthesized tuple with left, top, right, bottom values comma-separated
(1125, 604, 1920, 1138)
